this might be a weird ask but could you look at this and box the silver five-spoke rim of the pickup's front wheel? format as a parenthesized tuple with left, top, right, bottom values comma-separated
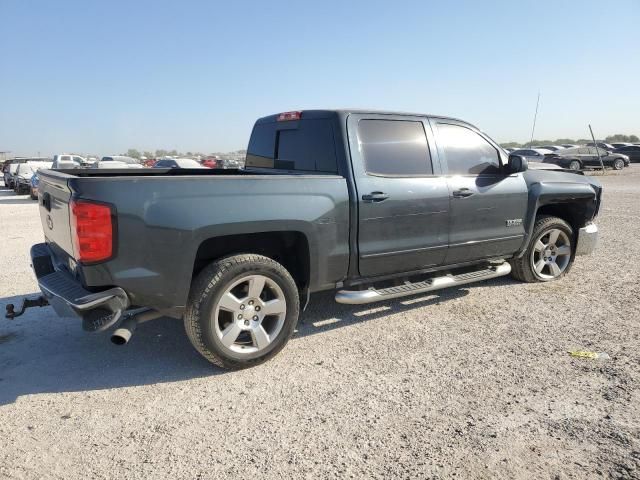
(531, 228, 571, 280)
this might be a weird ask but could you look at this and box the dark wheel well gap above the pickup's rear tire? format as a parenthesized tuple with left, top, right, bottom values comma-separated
(193, 232, 309, 290)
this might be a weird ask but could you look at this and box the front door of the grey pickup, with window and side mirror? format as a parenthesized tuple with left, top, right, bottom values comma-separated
(431, 119, 528, 264)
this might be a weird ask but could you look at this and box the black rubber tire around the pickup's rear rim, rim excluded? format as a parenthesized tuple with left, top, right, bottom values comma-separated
(184, 254, 300, 369)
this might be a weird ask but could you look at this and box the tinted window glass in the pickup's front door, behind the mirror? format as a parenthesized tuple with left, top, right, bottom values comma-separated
(438, 123, 500, 175)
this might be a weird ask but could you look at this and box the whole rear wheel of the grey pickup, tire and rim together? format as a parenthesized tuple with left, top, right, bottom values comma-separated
(184, 254, 300, 369)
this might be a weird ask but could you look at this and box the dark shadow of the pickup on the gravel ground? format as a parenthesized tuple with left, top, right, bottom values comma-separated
(0, 279, 504, 405)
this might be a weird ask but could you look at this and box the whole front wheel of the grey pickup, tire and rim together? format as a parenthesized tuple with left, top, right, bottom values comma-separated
(510, 215, 575, 282)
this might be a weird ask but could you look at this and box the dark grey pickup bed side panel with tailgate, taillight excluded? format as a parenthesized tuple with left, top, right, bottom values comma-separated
(40, 169, 349, 317)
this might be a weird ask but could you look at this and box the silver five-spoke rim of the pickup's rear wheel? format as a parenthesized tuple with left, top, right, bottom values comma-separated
(211, 275, 287, 355)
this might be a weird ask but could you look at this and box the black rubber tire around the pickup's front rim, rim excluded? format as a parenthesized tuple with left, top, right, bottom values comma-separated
(509, 215, 575, 283)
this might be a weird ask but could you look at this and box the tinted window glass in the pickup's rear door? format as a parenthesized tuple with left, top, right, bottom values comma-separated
(358, 120, 433, 176)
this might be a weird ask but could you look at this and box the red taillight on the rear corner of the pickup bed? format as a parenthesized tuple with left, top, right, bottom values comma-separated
(71, 200, 113, 263)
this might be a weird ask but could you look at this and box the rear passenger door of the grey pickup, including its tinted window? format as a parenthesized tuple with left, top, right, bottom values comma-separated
(347, 114, 449, 276)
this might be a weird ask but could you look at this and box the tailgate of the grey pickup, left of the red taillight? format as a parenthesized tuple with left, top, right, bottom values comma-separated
(38, 170, 73, 260)
